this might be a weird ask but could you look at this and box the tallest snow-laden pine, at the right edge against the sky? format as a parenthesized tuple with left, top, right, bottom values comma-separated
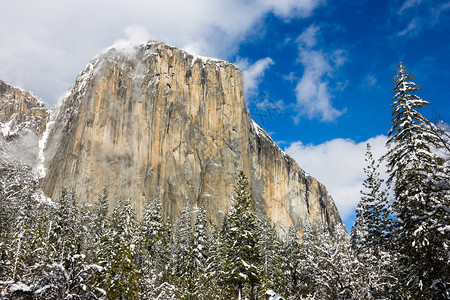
(385, 63, 450, 299)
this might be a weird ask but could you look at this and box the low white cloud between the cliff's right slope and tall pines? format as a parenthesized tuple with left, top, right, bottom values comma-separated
(285, 135, 387, 222)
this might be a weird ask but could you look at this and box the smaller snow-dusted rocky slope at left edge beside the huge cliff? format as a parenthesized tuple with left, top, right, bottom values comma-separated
(0, 80, 49, 202)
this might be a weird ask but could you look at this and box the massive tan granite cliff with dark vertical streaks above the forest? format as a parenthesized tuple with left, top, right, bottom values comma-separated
(41, 42, 341, 231)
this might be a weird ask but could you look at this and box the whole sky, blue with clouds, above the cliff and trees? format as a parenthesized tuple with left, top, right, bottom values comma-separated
(0, 0, 450, 228)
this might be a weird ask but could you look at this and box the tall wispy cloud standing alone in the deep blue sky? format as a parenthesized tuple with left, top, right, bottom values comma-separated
(294, 25, 346, 123)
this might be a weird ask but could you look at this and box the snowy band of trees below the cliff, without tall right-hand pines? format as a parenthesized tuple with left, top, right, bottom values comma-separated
(0, 172, 400, 299)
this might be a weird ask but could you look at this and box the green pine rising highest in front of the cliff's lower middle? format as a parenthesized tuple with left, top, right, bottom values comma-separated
(223, 171, 261, 299)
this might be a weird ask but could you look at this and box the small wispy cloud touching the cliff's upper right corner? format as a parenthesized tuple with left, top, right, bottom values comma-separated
(235, 57, 274, 99)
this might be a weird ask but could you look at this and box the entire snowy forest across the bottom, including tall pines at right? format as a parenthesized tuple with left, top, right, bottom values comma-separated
(0, 64, 450, 300)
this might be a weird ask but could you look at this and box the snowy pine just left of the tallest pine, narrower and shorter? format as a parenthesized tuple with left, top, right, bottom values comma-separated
(351, 144, 390, 253)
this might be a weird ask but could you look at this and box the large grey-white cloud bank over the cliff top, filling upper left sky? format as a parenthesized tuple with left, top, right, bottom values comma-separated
(0, 0, 323, 103)
